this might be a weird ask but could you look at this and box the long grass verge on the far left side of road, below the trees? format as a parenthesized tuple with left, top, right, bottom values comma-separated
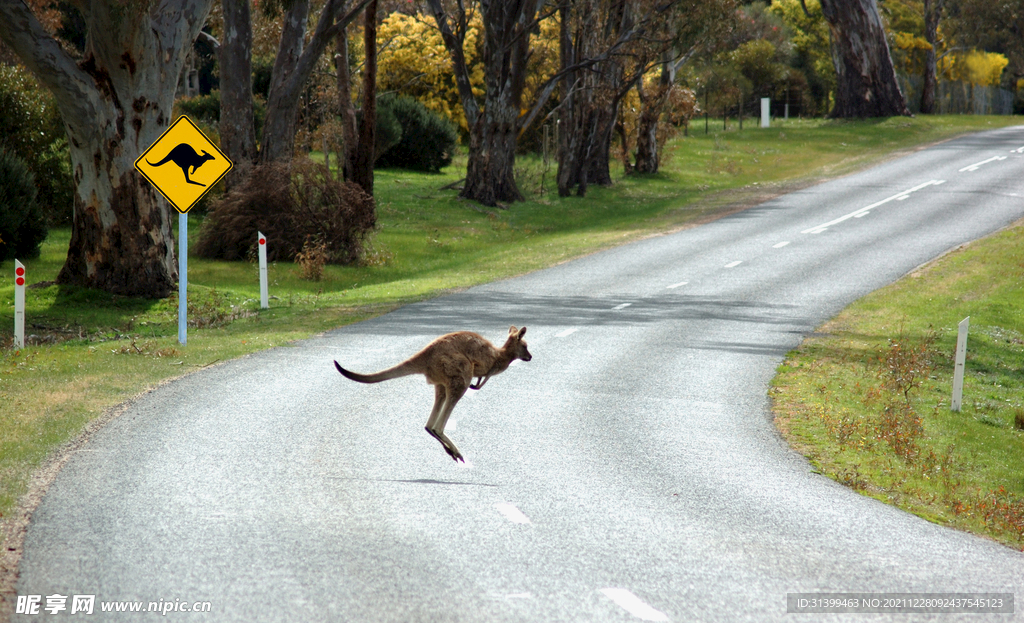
(0, 111, 1019, 520)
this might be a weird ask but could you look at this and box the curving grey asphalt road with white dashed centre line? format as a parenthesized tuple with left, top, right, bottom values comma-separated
(15, 127, 1024, 622)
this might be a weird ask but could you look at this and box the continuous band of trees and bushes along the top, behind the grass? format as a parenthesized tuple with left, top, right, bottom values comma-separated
(0, 0, 1024, 297)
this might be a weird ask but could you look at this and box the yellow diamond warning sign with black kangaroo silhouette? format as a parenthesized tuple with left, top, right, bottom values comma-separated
(135, 115, 231, 213)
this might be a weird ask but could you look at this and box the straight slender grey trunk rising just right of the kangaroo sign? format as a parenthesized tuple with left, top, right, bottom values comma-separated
(219, 0, 257, 189)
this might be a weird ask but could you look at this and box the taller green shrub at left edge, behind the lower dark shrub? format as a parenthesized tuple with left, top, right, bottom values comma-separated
(0, 65, 75, 224)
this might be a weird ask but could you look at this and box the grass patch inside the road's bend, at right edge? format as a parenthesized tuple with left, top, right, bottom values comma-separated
(772, 221, 1024, 548)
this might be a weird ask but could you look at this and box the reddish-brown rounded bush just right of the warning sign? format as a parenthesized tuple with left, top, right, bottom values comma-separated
(195, 159, 376, 263)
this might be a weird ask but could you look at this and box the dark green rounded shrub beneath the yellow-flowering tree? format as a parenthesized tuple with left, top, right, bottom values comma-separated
(377, 95, 459, 172)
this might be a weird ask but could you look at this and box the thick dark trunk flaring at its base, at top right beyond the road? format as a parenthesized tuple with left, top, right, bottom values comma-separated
(821, 0, 910, 119)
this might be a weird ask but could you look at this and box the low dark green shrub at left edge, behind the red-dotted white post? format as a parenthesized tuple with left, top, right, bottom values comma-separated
(0, 149, 46, 261)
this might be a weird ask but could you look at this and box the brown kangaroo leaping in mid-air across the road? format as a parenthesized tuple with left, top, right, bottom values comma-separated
(334, 327, 534, 463)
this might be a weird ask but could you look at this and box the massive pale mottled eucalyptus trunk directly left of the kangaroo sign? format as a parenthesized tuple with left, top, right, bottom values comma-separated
(0, 0, 211, 297)
